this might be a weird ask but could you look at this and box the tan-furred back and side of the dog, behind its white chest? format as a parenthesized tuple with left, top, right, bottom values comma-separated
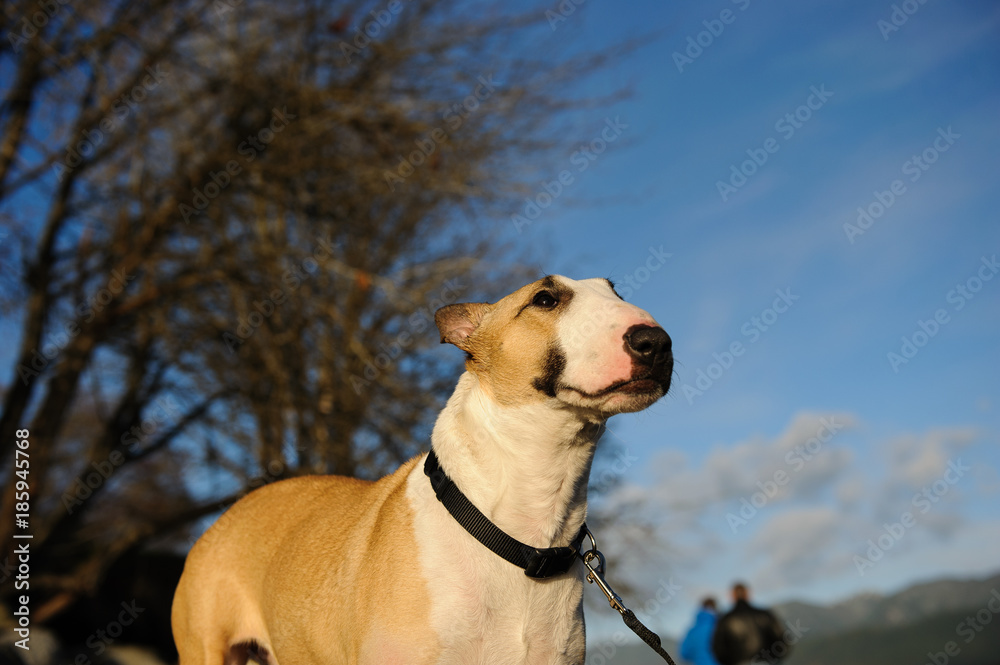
(173, 460, 438, 665)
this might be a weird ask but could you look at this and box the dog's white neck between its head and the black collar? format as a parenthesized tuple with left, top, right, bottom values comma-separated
(432, 372, 604, 547)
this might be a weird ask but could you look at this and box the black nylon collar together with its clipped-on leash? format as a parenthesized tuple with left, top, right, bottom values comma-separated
(424, 448, 677, 665)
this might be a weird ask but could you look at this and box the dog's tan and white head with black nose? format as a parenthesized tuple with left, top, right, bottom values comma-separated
(435, 275, 674, 416)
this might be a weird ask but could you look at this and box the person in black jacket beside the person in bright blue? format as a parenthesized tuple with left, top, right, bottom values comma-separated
(712, 583, 791, 665)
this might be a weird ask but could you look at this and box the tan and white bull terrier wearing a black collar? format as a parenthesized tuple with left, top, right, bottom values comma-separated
(172, 275, 673, 665)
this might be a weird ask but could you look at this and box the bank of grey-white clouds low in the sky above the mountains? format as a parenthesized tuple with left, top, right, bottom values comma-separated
(605, 412, 996, 598)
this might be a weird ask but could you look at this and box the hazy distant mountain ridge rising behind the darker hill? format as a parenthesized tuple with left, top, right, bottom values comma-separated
(774, 574, 1000, 639)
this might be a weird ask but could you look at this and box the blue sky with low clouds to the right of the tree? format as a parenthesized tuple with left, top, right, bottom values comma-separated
(508, 0, 1000, 639)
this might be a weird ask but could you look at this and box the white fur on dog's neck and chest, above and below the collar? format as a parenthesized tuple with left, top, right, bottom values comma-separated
(407, 373, 599, 665)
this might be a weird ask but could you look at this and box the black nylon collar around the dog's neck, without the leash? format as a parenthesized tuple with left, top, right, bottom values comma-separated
(424, 450, 587, 578)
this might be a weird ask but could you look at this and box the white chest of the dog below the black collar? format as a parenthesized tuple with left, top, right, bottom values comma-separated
(407, 464, 585, 665)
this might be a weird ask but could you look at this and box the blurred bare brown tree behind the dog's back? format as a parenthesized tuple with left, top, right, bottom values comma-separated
(0, 0, 624, 621)
